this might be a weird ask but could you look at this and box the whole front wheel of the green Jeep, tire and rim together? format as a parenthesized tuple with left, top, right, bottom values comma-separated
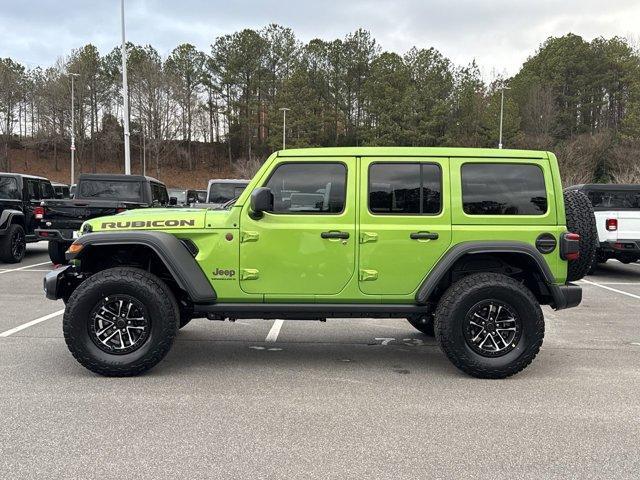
(63, 267, 180, 377)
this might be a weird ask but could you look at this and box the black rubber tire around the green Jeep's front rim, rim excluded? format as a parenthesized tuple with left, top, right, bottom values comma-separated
(63, 267, 180, 377)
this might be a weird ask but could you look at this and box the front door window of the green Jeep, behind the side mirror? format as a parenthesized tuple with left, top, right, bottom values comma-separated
(265, 163, 347, 213)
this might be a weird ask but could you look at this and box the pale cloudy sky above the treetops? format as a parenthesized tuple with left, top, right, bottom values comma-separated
(0, 0, 640, 77)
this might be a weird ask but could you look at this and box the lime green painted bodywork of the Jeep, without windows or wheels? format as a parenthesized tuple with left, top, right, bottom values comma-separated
(81, 147, 567, 303)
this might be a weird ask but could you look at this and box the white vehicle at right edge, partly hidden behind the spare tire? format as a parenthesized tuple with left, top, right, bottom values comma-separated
(567, 183, 640, 268)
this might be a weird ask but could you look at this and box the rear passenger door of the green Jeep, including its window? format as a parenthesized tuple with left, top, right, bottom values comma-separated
(358, 157, 451, 295)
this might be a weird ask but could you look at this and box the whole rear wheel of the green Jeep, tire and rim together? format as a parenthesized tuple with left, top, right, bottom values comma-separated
(434, 273, 544, 378)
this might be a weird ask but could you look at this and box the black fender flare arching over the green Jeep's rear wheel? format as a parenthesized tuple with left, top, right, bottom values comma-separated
(416, 242, 555, 305)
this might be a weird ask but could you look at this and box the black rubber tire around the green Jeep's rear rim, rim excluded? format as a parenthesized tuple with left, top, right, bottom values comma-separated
(434, 273, 544, 378)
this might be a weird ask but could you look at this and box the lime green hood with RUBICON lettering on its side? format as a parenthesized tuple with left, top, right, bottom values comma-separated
(80, 208, 207, 233)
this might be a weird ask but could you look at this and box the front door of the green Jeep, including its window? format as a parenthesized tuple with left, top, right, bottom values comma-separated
(240, 157, 357, 299)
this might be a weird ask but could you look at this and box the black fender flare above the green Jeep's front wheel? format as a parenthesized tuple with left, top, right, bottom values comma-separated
(67, 231, 217, 303)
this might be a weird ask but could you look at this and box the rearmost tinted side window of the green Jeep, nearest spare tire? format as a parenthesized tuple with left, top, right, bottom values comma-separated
(461, 163, 547, 215)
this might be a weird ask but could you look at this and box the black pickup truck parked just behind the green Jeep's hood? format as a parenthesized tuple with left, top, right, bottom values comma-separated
(35, 174, 169, 264)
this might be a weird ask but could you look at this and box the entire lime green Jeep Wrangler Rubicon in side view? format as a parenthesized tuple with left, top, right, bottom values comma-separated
(44, 147, 597, 378)
